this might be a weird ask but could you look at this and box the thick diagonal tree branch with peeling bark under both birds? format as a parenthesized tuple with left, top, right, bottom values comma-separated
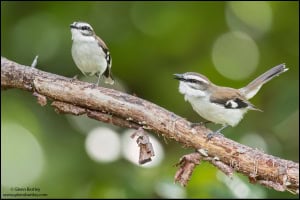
(1, 57, 299, 193)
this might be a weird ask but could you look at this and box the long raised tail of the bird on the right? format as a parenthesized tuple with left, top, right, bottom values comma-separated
(240, 63, 288, 99)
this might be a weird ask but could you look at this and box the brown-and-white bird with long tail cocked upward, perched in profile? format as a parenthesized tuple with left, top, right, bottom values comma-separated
(174, 64, 288, 137)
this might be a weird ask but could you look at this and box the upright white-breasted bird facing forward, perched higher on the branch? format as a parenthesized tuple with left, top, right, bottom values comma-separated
(70, 22, 114, 85)
